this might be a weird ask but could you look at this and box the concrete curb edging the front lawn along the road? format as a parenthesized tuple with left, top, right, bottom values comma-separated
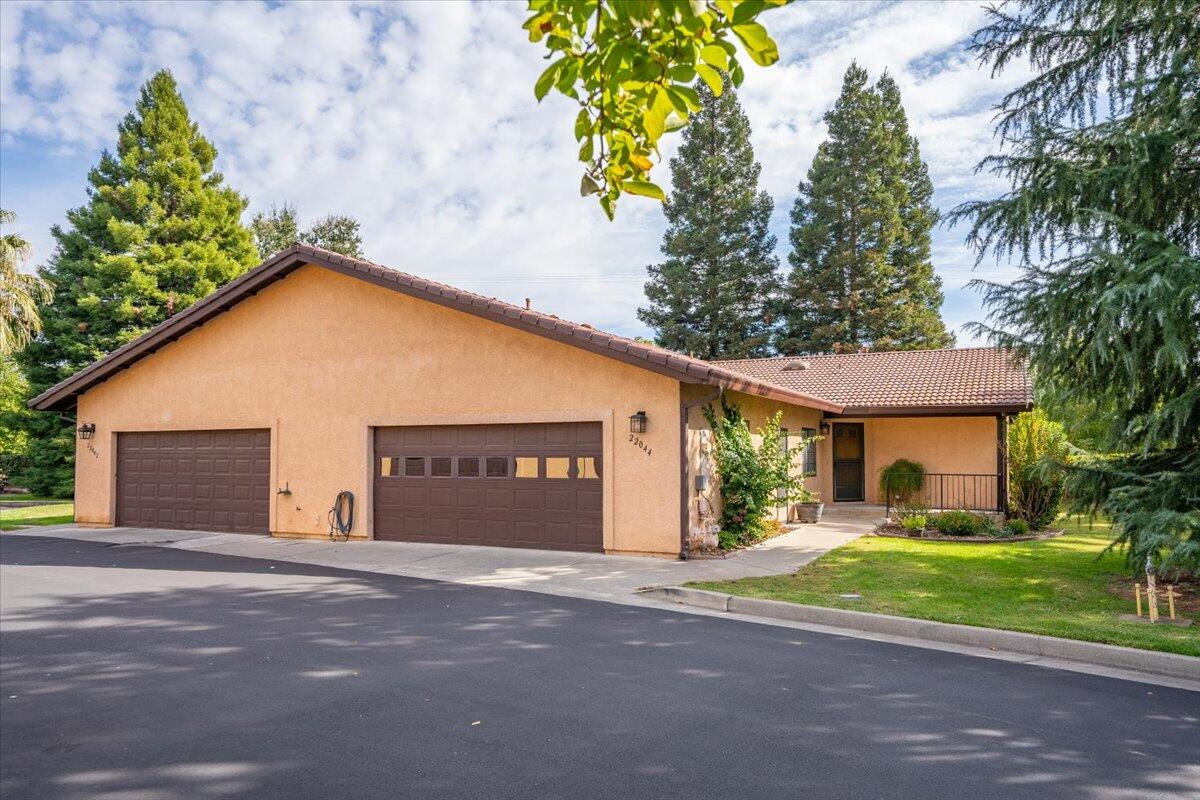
(640, 587, 1200, 682)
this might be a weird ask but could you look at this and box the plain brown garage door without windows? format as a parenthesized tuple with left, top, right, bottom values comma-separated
(116, 429, 271, 534)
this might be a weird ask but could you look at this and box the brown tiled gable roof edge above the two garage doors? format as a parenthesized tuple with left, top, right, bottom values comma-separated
(29, 245, 841, 411)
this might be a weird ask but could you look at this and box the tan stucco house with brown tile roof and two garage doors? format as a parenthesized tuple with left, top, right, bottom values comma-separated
(30, 246, 1031, 555)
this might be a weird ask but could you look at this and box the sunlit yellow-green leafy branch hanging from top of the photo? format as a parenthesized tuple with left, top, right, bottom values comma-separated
(524, 0, 788, 219)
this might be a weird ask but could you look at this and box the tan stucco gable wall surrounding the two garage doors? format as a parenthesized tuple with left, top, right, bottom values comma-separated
(76, 266, 680, 554)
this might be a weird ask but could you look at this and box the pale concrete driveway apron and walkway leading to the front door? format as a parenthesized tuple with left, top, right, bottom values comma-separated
(14, 518, 872, 604)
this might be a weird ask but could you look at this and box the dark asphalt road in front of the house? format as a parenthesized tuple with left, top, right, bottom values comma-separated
(0, 534, 1200, 800)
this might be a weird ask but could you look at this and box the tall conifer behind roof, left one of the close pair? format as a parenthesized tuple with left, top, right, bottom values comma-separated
(637, 80, 780, 359)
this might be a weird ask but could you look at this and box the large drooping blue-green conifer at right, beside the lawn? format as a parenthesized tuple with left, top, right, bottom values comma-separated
(954, 0, 1200, 573)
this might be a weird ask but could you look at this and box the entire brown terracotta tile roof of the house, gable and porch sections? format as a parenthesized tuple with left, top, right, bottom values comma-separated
(29, 245, 1032, 414)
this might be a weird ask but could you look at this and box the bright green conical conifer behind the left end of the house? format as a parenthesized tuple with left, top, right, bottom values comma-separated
(19, 71, 258, 495)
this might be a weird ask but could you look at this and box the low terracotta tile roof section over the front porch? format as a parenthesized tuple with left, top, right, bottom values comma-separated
(715, 348, 1033, 414)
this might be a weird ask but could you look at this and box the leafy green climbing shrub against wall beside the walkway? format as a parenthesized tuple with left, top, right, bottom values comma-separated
(704, 397, 818, 549)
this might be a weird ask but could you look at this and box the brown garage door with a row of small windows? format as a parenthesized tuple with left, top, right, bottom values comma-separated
(374, 422, 604, 552)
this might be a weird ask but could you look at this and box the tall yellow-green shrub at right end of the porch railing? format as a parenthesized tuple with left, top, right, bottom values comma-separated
(1008, 409, 1069, 530)
